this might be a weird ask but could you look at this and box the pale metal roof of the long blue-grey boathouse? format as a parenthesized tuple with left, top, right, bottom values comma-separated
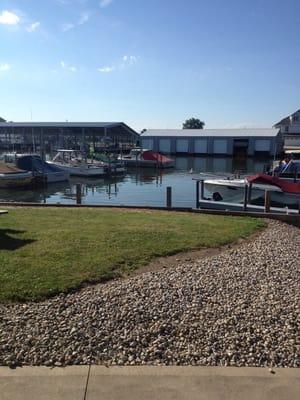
(141, 128, 280, 138)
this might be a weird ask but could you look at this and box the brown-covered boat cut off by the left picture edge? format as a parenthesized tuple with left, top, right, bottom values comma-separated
(0, 163, 34, 189)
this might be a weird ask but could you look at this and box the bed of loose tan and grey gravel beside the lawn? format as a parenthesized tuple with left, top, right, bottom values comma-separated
(0, 221, 300, 367)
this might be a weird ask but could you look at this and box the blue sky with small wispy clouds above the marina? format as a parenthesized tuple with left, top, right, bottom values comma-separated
(0, 0, 300, 130)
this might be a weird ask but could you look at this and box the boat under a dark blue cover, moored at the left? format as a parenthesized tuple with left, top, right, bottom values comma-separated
(4, 153, 70, 183)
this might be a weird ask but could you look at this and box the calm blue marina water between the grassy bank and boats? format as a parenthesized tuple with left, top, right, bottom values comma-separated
(0, 157, 268, 207)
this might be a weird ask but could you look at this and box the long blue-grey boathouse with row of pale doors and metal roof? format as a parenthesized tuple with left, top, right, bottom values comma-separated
(140, 128, 283, 156)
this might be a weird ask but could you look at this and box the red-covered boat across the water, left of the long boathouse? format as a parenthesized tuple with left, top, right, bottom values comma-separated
(118, 147, 175, 168)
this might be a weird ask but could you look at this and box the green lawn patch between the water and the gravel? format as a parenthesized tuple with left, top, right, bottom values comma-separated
(0, 208, 264, 302)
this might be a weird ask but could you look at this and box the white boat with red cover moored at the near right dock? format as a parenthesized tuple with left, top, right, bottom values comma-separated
(204, 173, 300, 208)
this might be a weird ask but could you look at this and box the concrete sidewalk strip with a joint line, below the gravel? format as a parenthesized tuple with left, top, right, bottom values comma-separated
(0, 366, 300, 400)
